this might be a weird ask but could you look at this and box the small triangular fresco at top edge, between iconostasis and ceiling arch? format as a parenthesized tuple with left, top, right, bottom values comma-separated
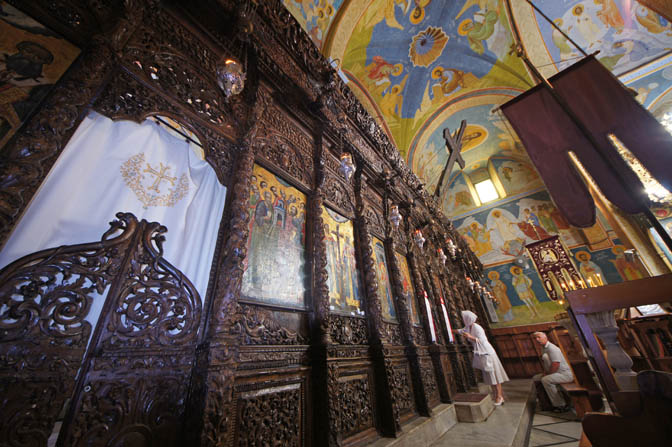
(282, 0, 343, 49)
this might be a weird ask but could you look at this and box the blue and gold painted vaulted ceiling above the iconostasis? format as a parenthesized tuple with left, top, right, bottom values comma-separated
(283, 0, 672, 216)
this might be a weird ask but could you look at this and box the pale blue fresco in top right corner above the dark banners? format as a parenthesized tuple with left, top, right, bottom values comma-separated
(516, 0, 672, 73)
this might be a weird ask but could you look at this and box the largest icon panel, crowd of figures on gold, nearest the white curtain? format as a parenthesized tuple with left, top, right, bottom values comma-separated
(242, 165, 306, 308)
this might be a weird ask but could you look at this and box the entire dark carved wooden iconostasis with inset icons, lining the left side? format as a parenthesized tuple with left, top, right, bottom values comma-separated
(0, 0, 489, 446)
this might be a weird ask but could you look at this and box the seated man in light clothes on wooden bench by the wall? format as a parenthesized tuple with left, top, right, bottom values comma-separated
(532, 332, 574, 413)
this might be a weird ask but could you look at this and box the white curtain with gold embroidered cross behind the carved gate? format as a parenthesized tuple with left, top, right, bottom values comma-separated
(0, 113, 226, 302)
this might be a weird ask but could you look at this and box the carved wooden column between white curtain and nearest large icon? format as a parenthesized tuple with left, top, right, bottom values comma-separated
(185, 100, 265, 447)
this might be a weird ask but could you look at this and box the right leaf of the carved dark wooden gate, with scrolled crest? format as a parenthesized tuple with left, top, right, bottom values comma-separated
(59, 213, 201, 446)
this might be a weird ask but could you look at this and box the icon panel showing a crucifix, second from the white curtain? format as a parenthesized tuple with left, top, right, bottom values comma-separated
(322, 207, 364, 316)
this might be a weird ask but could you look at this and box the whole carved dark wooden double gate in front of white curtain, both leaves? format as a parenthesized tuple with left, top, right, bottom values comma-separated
(0, 213, 201, 446)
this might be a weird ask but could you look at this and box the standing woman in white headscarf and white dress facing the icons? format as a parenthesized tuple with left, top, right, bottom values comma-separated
(457, 310, 509, 405)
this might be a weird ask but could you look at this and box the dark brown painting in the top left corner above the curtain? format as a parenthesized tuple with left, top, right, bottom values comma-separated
(0, 1, 79, 148)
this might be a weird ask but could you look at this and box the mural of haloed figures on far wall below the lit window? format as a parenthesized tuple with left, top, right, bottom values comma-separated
(462, 190, 652, 327)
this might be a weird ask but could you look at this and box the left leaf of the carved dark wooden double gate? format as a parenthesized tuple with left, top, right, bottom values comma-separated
(0, 222, 118, 446)
